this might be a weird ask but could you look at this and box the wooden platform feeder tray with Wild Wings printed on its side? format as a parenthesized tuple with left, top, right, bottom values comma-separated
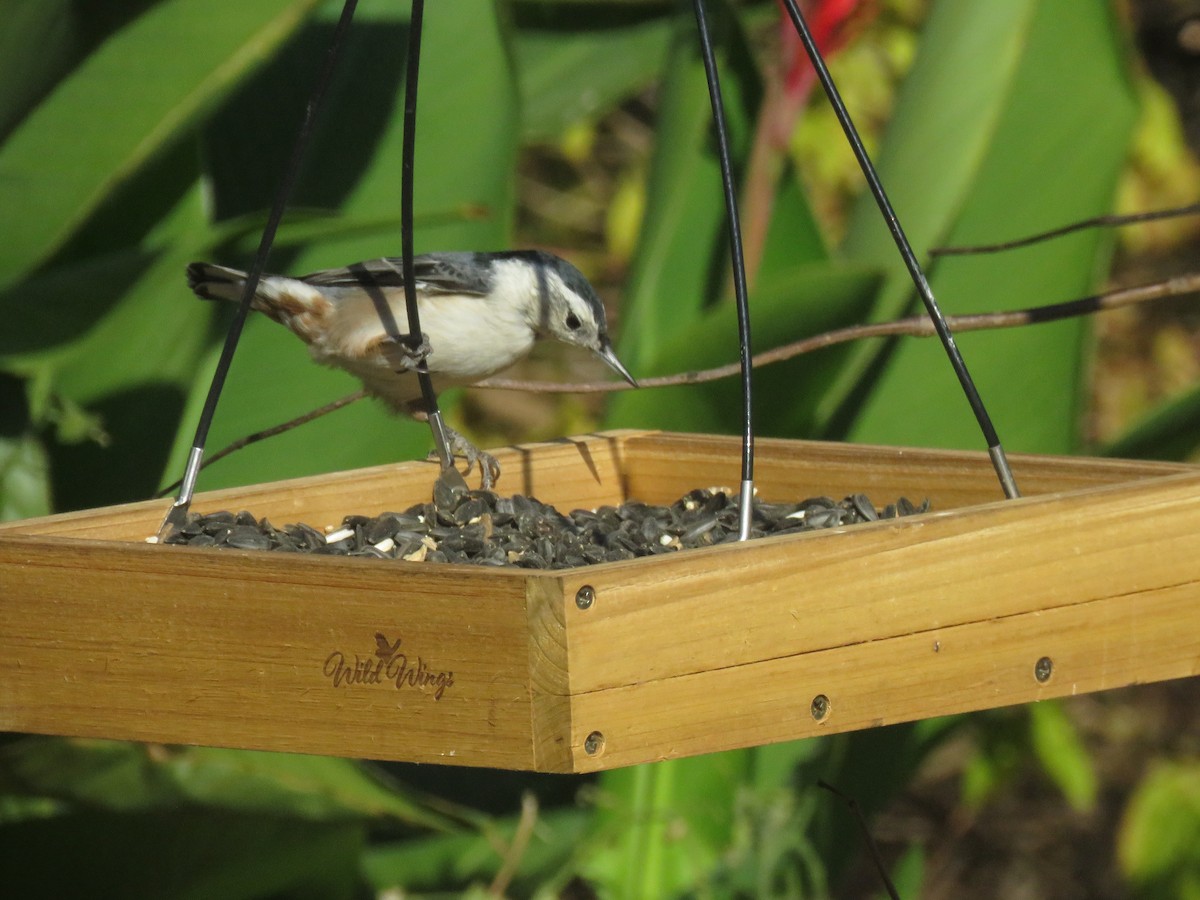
(0, 432, 1200, 772)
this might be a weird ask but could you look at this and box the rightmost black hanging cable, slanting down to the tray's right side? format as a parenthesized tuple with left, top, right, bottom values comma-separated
(784, 0, 1020, 498)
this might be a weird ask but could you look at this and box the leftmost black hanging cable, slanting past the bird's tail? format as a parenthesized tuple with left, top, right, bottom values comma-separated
(158, 0, 359, 536)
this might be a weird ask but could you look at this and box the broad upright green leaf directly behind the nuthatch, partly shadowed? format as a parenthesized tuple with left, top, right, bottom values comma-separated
(163, 0, 518, 489)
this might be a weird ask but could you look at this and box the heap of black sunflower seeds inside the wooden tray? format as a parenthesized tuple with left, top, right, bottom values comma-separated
(164, 482, 929, 569)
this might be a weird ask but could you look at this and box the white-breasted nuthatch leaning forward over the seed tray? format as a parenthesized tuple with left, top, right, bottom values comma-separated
(187, 250, 637, 487)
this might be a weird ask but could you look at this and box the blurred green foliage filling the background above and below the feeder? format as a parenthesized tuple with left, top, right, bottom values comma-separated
(0, 0, 1180, 898)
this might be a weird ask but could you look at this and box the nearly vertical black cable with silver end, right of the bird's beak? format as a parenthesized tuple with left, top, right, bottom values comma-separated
(695, 0, 754, 541)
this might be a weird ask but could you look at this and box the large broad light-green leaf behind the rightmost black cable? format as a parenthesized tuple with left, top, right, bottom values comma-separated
(821, 2, 1134, 451)
